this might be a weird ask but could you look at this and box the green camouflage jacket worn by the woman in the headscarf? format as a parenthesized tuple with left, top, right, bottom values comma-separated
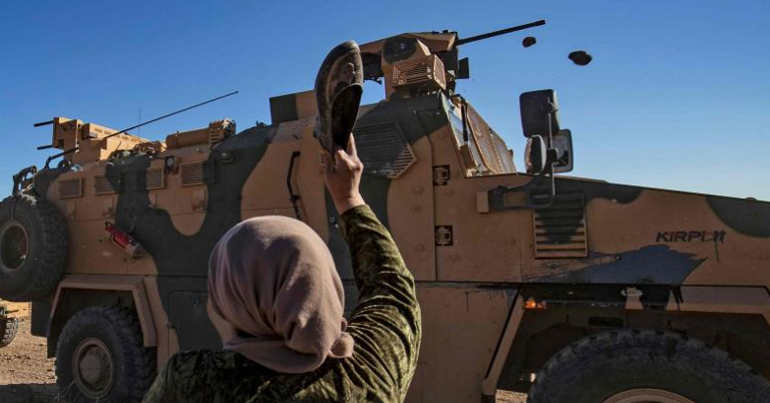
(144, 206, 422, 403)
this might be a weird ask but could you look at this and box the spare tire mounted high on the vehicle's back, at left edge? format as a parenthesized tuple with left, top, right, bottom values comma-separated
(0, 194, 69, 301)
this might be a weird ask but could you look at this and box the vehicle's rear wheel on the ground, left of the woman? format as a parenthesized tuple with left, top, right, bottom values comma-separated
(56, 306, 155, 403)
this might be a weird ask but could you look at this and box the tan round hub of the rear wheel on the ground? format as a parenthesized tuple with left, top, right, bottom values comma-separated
(72, 338, 113, 399)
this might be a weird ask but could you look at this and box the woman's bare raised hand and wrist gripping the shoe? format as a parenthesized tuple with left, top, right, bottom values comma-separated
(321, 135, 365, 214)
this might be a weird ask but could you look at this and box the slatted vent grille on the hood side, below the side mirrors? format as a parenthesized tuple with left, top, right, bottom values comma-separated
(533, 193, 588, 258)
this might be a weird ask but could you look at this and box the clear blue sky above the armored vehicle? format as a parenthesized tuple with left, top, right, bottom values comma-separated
(0, 0, 770, 200)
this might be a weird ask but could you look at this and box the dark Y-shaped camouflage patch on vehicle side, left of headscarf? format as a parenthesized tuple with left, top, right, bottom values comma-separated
(106, 128, 274, 349)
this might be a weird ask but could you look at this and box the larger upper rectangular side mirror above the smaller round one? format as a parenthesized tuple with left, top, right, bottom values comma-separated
(519, 90, 559, 137)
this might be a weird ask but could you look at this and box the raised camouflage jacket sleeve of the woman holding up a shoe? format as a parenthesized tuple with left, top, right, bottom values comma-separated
(340, 205, 422, 400)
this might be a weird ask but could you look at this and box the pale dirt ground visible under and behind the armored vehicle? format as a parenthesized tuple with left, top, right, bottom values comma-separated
(0, 301, 526, 403)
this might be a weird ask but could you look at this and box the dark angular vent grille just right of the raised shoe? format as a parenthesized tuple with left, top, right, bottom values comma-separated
(353, 123, 417, 179)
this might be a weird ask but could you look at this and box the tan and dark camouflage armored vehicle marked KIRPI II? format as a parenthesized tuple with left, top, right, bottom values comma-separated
(0, 19, 770, 402)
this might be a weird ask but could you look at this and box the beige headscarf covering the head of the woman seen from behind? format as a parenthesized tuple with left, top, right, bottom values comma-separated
(208, 216, 353, 373)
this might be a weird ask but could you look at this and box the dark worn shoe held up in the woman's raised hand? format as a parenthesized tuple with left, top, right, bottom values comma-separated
(315, 41, 364, 154)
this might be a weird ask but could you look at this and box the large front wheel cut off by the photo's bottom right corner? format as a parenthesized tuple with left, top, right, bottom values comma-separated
(527, 330, 770, 403)
